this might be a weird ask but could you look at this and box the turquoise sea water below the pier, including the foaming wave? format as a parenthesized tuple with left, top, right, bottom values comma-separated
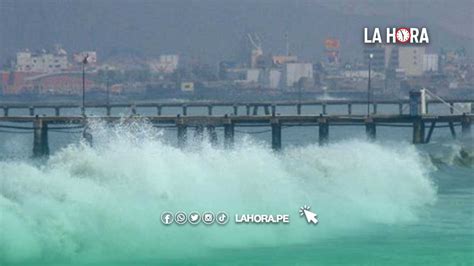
(0, 105, 474, 265)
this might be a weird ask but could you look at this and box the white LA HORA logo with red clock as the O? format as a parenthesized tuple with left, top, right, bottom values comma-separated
(364, 27, 430, 44)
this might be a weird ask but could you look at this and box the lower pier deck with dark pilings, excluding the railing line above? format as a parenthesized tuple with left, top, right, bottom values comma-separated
(0, 114, 468, 157)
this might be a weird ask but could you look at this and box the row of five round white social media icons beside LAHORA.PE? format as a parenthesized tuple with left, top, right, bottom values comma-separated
(161, 211, 229, 225)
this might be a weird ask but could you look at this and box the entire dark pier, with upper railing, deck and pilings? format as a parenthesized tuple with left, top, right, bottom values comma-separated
(0, 92, 474, 157)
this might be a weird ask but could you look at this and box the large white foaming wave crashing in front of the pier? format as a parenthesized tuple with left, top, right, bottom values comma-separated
(0, 123, 436, 263)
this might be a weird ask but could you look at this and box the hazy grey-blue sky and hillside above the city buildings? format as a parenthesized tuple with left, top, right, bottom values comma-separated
(0, 0, 474, 63)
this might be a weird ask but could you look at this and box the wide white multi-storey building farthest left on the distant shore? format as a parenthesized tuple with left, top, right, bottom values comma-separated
(16, 49, 69, 73)
